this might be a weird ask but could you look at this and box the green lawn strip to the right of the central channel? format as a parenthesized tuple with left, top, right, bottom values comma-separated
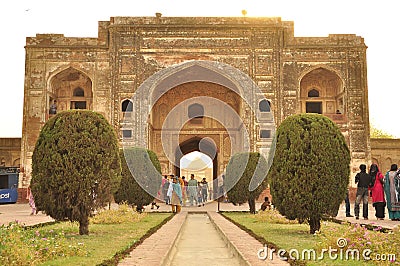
(223, 212, 372, 266)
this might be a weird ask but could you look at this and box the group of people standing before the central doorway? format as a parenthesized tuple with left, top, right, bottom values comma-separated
(161, 174, 209, 213)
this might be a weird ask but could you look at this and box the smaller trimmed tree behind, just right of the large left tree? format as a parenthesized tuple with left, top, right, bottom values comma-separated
(114, 147, 162, 211)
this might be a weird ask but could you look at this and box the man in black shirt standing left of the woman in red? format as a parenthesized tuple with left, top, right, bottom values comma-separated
(354, 164, 372, 220)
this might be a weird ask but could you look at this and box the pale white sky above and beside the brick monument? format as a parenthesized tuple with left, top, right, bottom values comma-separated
(0, 0, 400, 138)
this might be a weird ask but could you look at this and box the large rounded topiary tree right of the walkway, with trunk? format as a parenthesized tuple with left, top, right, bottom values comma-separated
(268, 114, 350, 234)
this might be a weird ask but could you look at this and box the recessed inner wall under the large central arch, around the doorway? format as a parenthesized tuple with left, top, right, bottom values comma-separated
(149, 81, 239, 179)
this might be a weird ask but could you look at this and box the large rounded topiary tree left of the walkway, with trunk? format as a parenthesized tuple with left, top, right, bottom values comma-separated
(31, 110, 121, 234)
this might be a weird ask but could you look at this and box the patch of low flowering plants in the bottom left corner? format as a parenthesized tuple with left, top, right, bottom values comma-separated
(0, 222, 87, 265)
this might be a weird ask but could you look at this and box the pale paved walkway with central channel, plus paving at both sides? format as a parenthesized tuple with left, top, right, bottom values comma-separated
(0, 202, 400, 266)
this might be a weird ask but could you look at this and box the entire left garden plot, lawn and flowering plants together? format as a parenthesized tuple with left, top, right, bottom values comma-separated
(0, 211, 173, 266)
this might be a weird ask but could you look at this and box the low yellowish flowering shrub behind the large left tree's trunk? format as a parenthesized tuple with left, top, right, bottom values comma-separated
(90, 203, 147, 224)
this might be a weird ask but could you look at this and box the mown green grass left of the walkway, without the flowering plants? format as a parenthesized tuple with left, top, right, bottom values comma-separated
(42, 213, 172, 266)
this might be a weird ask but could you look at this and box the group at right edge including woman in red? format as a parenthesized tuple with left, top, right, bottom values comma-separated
(354, 164, 400, 221)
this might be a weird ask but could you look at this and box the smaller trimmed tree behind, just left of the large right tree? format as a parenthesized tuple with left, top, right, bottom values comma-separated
(224, 152, 268, 213)
